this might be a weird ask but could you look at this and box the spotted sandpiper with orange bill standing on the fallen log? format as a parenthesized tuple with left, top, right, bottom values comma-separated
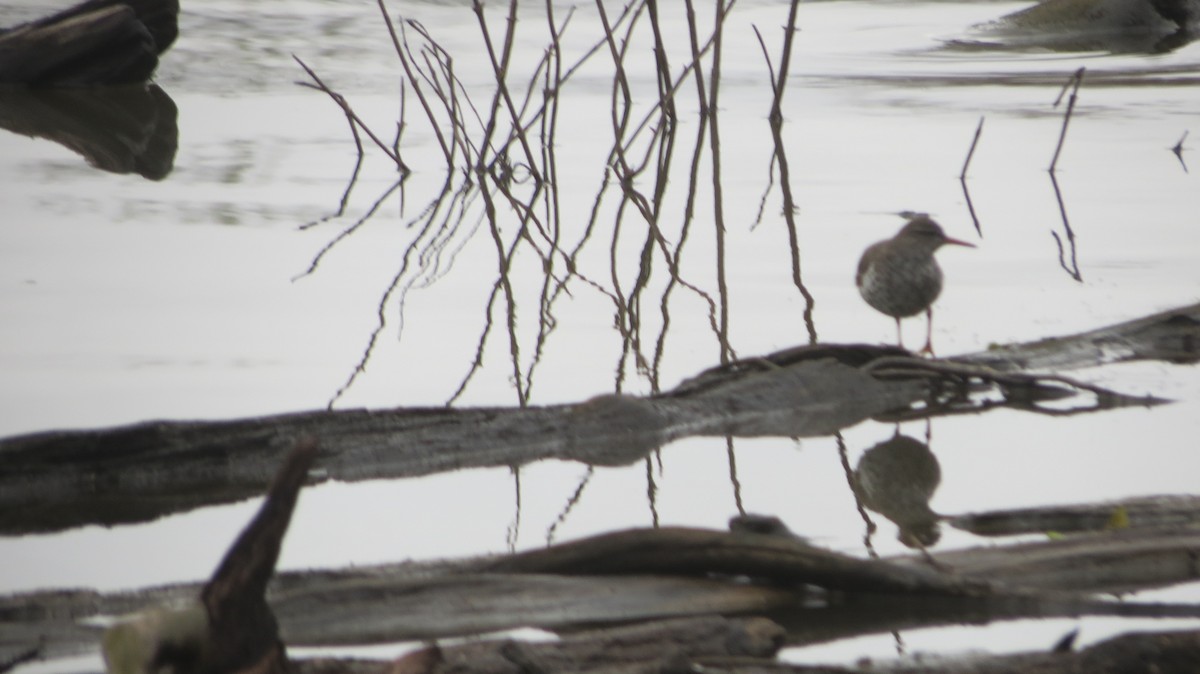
(854, 213, 974, 354)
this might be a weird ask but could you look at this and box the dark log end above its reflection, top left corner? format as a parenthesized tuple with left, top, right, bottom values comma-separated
(0, 0, 179, 86)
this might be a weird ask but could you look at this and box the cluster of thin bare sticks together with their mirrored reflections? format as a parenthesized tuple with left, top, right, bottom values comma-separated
(296, 0, 816, 407)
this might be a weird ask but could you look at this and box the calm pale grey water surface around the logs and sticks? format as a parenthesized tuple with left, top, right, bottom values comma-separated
(0, 0, 1200, 669)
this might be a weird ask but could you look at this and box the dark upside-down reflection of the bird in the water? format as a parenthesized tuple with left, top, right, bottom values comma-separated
(853, 433, 942, 548)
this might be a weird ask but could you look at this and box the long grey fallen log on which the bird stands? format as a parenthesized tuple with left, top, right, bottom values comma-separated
(0, 305, 1200, 534)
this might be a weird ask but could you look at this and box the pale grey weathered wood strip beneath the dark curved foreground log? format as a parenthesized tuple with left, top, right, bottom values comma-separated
(271, 573, 820, 645)
